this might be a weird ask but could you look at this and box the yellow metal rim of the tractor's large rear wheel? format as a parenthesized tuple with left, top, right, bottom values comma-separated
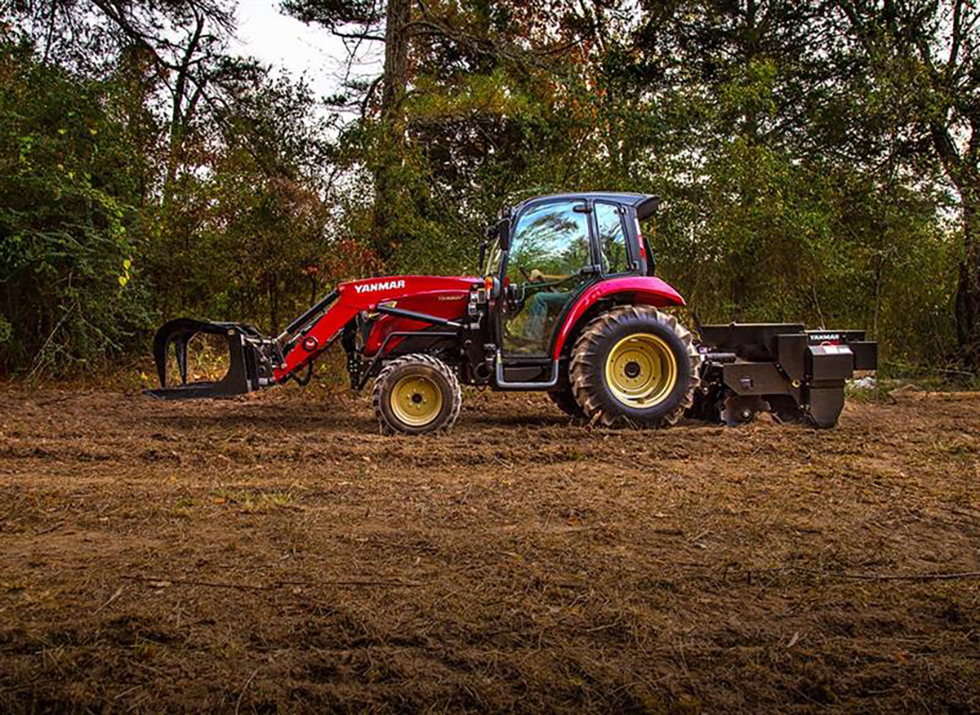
(606, 333, 677, 409)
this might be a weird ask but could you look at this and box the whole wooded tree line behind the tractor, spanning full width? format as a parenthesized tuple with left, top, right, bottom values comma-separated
(0, 0, 980, 379)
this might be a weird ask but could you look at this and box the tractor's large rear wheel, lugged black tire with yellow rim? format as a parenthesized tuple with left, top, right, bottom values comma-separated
(569, 305, 701, 427)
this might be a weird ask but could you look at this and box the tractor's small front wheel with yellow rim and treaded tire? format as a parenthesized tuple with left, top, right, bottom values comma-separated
(371, 354, 463, 435)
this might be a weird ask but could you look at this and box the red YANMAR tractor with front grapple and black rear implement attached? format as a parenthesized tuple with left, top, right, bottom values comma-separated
(150, 193, 877, 434)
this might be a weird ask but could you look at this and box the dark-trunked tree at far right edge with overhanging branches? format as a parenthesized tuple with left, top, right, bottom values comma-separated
(838, 0, 980, 369)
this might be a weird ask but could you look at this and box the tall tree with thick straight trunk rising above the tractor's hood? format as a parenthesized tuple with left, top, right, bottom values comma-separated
(283, 0, 604, 260)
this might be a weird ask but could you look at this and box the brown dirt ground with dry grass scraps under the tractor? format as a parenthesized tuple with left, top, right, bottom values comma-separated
(0, 388, 980, 713)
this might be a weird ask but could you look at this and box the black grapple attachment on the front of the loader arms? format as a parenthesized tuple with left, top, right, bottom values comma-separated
(147, 318, 281, 400)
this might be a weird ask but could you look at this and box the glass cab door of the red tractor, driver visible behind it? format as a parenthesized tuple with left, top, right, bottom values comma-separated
(500, 199, 599, 358)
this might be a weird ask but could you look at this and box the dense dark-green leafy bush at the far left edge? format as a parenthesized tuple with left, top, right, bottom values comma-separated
(0, 37, 154, 374)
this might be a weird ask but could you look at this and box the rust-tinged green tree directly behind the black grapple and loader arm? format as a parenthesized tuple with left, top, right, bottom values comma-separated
(144, 70, 372, 332)
